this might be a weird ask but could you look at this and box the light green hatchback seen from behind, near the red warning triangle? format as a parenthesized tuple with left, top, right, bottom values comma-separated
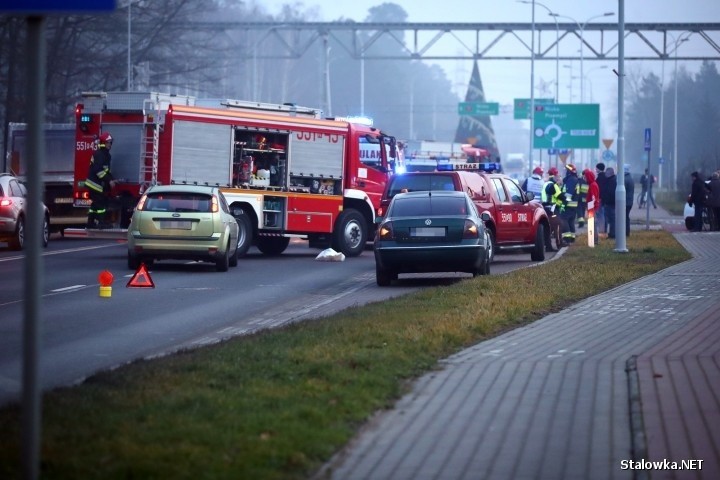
(127, 184, 239, 272)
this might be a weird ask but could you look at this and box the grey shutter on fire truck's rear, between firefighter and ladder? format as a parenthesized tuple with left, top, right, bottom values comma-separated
(103, 123, 144, 183)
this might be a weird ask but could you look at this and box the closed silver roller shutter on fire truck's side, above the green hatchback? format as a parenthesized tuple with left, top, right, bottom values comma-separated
(170, 120, 233, 185)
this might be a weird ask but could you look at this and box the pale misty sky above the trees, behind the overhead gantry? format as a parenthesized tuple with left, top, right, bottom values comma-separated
(256, 0, 720, 137)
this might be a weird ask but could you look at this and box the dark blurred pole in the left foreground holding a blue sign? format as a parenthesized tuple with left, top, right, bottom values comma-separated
(22, 17, 46, 480)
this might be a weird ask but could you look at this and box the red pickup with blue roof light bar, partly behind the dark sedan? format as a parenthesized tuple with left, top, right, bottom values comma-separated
(377, 162, 550, 262)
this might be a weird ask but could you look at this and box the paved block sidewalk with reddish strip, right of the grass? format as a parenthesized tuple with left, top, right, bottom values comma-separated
(317, 209, 720, 480)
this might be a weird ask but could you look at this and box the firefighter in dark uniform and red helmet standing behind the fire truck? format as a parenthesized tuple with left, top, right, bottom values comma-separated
(85, 132, 115, 228)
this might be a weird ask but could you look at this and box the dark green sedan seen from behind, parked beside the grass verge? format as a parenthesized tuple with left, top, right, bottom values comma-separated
(375, 191, 490, 286)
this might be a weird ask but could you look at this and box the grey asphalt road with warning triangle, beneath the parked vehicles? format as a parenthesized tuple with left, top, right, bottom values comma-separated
(0, 237, 544, 404)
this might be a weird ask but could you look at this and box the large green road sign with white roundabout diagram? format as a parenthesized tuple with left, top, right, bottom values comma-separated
(533, 103, 600, 149)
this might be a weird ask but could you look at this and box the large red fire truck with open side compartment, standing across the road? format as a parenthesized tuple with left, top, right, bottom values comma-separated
(74, 92, 397, 256)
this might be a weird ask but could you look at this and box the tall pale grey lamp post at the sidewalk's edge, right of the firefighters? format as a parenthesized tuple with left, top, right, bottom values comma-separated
(615, 0, 628, 253)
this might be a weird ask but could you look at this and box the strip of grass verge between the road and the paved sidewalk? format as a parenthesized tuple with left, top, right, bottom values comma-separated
(0, 231, 689, 479)
